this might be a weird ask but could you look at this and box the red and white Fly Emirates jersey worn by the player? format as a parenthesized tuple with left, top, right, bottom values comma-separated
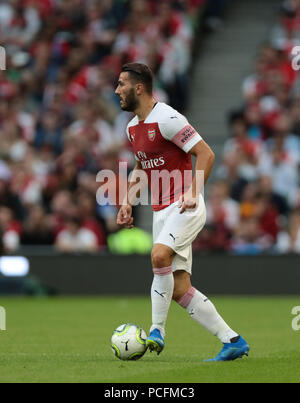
(126, 102, 202, 211)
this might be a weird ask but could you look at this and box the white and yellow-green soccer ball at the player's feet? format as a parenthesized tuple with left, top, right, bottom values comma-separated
(111, 323, 147, 360)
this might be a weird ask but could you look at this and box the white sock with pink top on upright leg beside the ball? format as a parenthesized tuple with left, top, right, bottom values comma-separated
(150, 266, 174, 337)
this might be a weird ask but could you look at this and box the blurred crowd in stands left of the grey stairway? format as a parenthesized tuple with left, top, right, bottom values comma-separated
(0, 0, 206, 253)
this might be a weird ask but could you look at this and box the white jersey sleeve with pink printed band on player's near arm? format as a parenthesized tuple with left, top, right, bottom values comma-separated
(159, 110, 202, 153)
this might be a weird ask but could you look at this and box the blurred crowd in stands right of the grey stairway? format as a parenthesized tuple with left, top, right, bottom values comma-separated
(194, 0, 300, 254)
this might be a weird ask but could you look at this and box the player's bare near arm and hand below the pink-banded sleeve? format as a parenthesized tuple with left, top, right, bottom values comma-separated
(178, 140, 215, 214)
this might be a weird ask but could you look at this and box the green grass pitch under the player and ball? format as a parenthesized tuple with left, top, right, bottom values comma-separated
(0, 296, 300, 383)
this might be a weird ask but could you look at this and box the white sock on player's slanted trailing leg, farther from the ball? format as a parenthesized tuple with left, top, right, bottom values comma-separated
(178, 287, 238, 343)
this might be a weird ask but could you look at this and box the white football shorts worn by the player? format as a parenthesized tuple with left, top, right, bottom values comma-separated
(153, 194, 206, 274)
